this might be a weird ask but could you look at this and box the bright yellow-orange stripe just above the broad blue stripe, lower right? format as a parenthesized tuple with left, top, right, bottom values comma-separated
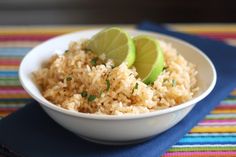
(190, 126, 236, 133)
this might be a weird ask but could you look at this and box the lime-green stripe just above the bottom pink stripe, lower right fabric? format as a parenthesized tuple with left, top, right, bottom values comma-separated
(168, 146, 236, 152)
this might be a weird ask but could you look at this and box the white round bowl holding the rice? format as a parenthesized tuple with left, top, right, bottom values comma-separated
(19, 29, 216, 144)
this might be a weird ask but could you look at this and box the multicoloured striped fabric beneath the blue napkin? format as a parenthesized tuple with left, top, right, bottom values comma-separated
(0, 24, 236, 157)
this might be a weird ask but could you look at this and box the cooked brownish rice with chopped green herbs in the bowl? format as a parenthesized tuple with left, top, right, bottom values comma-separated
(33, 41, 198, 115)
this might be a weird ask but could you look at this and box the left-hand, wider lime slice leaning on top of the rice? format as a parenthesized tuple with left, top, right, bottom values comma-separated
(87, 27, 135, 67)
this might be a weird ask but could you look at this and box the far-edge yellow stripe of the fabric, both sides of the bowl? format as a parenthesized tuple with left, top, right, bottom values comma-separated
(0, 24, 236, 35)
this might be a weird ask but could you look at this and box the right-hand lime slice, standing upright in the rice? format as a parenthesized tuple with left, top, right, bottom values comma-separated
(134, 35, 164, 84)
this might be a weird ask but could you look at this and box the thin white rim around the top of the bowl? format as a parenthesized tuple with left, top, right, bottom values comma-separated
(19, 28, 217, 120)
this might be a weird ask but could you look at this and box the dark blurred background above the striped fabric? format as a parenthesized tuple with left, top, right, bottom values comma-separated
(0, 0, 236, 25)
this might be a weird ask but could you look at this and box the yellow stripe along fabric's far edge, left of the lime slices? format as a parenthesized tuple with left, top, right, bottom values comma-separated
(0, 25, 134, 35)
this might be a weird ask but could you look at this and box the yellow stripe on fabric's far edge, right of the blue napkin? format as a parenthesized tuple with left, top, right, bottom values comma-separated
(167, 24, 236, 33)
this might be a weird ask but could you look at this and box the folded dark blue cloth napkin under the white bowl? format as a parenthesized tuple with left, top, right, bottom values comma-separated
(0, 22, 236, 157)
